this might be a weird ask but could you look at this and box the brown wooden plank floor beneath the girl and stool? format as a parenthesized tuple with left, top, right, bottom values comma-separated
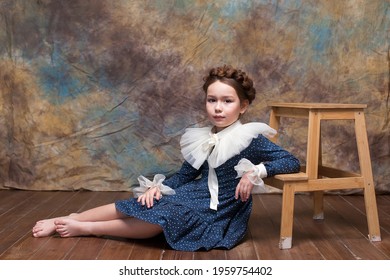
(0, 190, 390, 260)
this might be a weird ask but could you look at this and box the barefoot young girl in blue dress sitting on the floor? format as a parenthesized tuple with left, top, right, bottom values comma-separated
(32, 66, 299, 251)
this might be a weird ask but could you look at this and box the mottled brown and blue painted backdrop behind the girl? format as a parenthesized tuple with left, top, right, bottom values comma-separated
(0, 0, 390, 191)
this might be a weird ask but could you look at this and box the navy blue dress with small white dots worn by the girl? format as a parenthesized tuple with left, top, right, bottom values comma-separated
(115, 123, 299, 251)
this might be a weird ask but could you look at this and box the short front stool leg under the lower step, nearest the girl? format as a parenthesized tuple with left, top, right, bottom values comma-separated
(279, 184, 295, 249)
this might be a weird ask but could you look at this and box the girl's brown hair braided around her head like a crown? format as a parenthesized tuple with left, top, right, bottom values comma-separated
(203, 65, 256, 104)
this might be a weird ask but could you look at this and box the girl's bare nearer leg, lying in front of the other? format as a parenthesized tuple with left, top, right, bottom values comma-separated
(55, 217, 162, 239)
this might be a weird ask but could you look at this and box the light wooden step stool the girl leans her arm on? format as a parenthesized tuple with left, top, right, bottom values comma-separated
(265, 103, 381, 249)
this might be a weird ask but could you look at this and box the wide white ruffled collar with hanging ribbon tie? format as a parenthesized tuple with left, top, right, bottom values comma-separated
(180, 121, 276, 210)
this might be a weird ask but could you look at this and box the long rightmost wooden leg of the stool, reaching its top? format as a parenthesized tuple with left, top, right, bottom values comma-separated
(355, 112, 381, 241)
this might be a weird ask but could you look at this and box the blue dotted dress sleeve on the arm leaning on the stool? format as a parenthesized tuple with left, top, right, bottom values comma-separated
(255, 135, 300, 177)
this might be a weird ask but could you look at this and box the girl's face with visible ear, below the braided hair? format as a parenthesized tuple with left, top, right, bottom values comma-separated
(206, 81, 249, 132)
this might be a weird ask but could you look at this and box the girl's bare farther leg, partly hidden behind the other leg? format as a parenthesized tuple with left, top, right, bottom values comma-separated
(32, 203, 122, 237)
